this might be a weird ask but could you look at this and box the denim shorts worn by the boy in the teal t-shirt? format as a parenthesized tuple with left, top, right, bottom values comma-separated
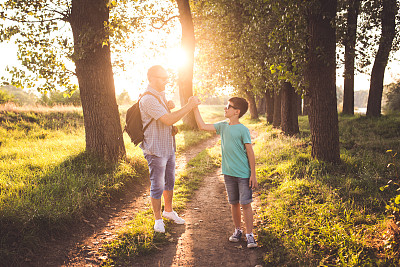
(224, 175, 253, 205)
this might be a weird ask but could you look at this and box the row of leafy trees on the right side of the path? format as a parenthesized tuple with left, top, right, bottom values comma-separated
(195, 0, 398, 162)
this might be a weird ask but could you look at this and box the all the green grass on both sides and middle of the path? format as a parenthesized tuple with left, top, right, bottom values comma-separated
(0, 106, 400, 266)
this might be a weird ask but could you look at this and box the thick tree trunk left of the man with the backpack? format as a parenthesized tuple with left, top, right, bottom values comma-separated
(69, 0, 126, 162)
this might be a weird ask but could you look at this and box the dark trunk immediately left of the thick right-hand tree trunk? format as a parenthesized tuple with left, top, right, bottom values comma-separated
(281, 82, 299, 135)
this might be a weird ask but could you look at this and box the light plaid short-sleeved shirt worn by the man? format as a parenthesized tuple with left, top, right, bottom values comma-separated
(139, 86, 176, 157)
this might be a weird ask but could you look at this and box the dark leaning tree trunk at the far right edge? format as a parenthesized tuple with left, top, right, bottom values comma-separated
(367, 0, 398, 117)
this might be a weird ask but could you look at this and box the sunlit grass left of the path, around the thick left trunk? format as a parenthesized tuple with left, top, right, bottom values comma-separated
(0, 103, 225, 265)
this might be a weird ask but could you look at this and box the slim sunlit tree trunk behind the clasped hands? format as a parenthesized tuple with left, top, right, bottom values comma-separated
(176, 0, 198, 129)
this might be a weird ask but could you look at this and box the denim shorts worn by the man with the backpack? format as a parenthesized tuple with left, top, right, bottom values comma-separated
(144, 154, 175, 199)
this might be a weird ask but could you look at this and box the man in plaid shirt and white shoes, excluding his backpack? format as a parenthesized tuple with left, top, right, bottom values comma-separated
(139, 65, 200, 233)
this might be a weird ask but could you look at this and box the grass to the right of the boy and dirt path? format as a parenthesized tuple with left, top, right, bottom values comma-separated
(254, 115, 400, 266)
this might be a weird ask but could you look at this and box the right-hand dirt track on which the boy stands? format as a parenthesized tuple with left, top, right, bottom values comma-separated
(129, 163, 262, 267)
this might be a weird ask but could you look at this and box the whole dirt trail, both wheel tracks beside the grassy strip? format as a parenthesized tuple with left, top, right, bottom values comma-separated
(32, 136, 262, 266)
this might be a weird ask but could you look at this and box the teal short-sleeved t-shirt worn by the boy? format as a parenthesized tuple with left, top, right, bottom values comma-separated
(214, 121, 251, 178)
